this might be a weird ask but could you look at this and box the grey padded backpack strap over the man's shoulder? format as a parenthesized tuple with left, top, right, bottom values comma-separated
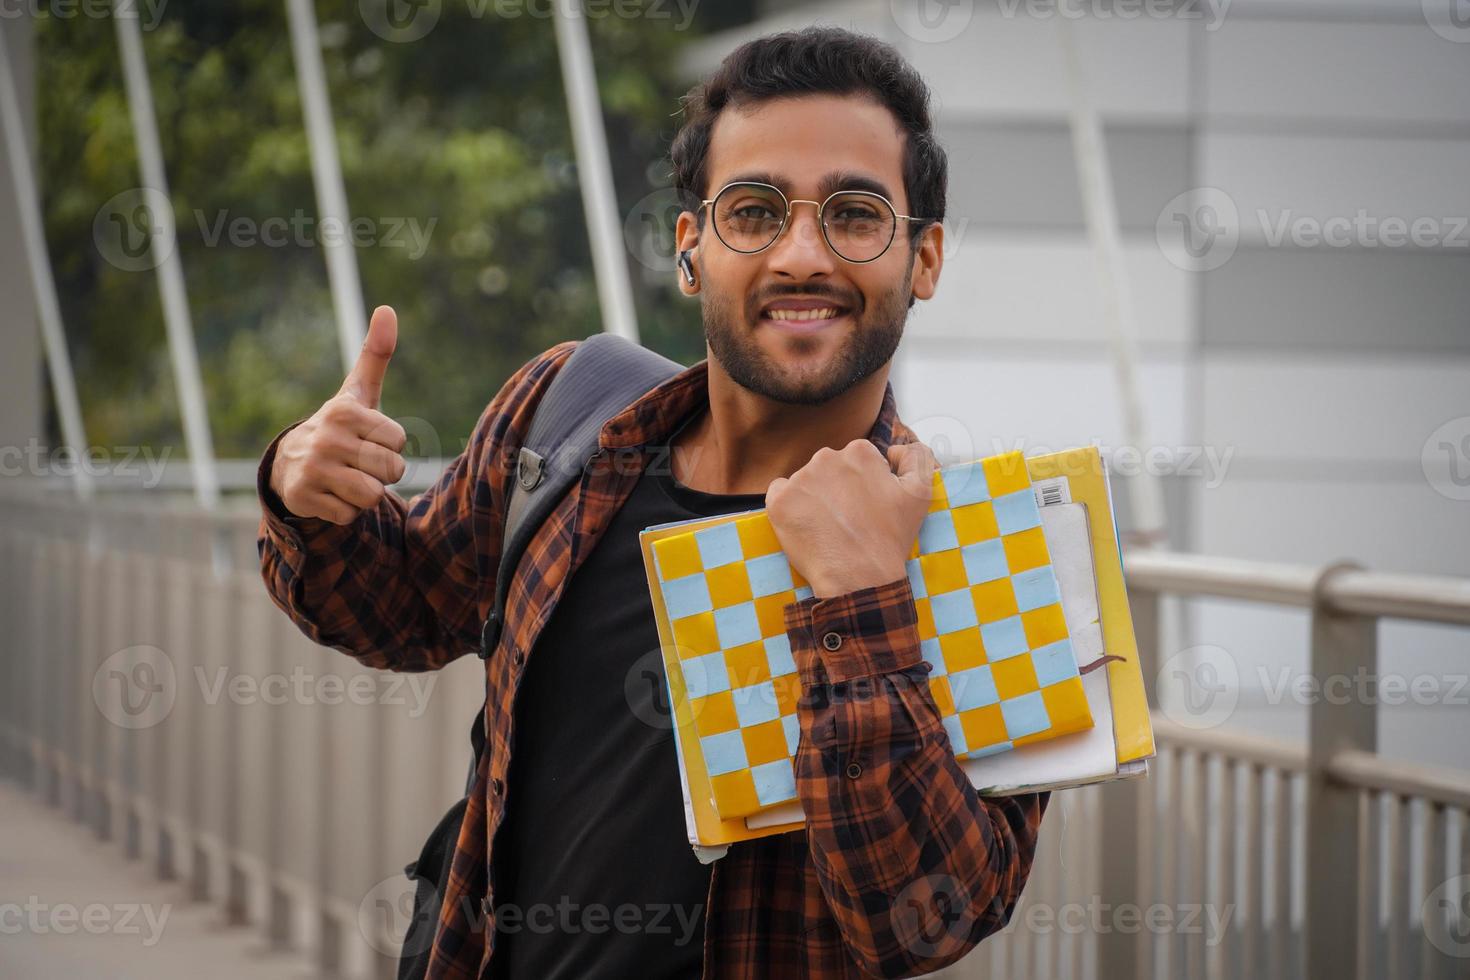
(466, 334, 685, 792)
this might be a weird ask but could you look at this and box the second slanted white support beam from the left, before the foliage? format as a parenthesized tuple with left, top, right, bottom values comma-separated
(112, 0, 219, 510)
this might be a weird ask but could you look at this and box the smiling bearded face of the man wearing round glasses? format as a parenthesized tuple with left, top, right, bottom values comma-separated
(678, 96, 942, 406)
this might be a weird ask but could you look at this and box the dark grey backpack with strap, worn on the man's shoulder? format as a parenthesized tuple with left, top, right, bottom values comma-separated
(398, 334, 685, 980)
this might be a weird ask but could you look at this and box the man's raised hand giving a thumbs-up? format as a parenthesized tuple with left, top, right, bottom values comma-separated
(270, 306, 407, 525)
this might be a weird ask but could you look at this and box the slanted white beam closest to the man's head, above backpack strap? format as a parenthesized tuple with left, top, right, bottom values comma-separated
(554, 0, 638, 344)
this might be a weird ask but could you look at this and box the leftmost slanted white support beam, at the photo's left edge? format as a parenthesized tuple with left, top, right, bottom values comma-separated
(0, 18, 94, 500)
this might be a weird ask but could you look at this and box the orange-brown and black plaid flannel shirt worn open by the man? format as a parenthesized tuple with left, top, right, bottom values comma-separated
(257, 341, 1048, 980)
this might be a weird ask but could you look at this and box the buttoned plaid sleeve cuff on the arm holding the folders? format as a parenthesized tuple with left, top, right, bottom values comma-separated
(784, 576, 923, 689)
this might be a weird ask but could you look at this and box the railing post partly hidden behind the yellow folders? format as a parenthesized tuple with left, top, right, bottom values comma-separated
(1094, 589, 1160, 980)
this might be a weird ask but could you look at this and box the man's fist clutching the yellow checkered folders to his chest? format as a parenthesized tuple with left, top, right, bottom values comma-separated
(766, 439, 938, 598)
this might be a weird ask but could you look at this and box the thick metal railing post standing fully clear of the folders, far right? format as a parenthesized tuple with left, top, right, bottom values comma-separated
(1302, 563, 1377, 977)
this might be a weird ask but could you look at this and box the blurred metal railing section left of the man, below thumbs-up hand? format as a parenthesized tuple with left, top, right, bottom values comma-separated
(0, 495, 484, 977)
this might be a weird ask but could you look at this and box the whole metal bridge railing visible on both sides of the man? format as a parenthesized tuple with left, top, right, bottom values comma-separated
(0, 494, 1470, 979)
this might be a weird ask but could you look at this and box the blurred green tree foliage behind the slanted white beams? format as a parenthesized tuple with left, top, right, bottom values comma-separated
(35, 0, 704, 457)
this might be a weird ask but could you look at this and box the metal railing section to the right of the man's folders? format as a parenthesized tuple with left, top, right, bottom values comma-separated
(1103, 551, 1470, 980)
